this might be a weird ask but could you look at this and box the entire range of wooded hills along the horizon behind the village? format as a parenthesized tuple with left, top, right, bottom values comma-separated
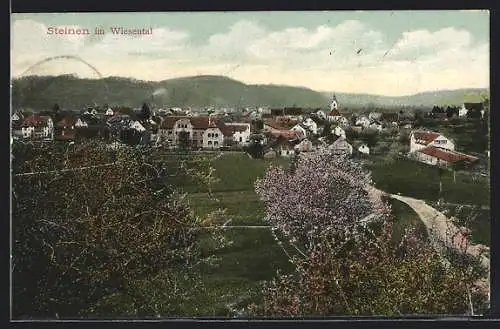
(12, 75, 489, 109)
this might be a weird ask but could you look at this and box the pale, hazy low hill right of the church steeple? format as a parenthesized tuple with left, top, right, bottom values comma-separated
(322, 88, 489, 107)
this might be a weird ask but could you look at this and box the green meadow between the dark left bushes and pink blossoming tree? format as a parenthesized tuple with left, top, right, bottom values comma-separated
(184, 154, 291, 316)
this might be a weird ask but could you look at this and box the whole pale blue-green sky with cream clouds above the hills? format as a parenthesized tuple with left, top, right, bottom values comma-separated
(11, 10, 490, 96)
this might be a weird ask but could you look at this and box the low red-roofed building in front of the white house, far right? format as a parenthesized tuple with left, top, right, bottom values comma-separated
(414, 146, 479, 168)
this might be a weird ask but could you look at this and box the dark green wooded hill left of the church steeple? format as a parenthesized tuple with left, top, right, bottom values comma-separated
(12, 75, 328, 109)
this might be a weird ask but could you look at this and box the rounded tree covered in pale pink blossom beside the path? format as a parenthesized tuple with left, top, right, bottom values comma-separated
(256, 149, 389, 250)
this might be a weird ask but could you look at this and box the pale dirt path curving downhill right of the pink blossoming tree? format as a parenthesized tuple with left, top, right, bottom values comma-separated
(370, 188, 490, 299)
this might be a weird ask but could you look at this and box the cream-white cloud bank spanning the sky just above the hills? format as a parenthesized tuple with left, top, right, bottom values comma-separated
(11, 16, 489, 95)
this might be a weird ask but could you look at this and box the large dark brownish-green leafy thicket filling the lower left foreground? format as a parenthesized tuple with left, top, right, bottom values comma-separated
(12, 142, 227, 318)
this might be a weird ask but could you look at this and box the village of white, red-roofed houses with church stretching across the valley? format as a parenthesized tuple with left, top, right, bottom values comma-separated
(12, 96, 489, 173)
